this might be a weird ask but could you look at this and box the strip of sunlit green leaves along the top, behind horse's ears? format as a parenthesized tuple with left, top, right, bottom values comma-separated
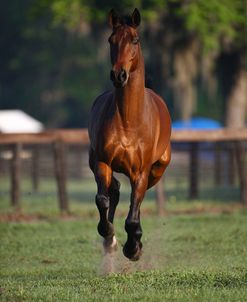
(47, 0, 247, 51)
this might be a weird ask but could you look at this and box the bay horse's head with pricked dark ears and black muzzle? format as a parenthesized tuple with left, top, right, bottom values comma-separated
(108, 9, 141, 87)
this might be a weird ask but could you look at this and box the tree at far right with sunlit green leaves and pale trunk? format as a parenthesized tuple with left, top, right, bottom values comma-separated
(179, 0, 247, 127)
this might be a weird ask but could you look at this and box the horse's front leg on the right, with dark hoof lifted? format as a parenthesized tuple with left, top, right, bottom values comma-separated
(123, 174, 148, 261)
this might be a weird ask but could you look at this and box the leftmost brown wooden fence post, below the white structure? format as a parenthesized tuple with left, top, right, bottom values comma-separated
(10, 143, 22, 209)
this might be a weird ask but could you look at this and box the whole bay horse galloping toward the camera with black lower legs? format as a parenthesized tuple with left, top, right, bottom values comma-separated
(88, 9, 171, 261)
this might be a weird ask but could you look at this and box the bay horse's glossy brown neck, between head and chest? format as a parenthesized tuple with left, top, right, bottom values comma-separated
(115, 52, 145, 127)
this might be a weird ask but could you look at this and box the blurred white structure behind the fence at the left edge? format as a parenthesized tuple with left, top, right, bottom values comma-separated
(0, 110, 44, 133)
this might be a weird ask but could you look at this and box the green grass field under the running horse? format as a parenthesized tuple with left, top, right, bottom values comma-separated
(0, 178, 247, 302)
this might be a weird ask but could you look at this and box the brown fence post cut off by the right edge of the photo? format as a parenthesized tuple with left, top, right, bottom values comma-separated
(235, 141, 247, 207)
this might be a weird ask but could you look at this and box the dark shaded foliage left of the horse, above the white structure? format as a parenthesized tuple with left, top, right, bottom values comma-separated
(0, 0, 108, 127)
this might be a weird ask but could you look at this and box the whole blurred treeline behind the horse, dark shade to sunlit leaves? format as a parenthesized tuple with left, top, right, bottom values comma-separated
(0, 0, 247, 127)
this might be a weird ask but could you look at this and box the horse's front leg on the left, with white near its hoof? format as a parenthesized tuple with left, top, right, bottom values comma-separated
(94, 162, 117, 253)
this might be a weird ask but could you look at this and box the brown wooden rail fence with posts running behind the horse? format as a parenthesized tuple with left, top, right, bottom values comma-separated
(0, 128, 247, 213)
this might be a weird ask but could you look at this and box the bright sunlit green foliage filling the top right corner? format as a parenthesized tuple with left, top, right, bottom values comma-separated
(178, 0, 247, 51)
